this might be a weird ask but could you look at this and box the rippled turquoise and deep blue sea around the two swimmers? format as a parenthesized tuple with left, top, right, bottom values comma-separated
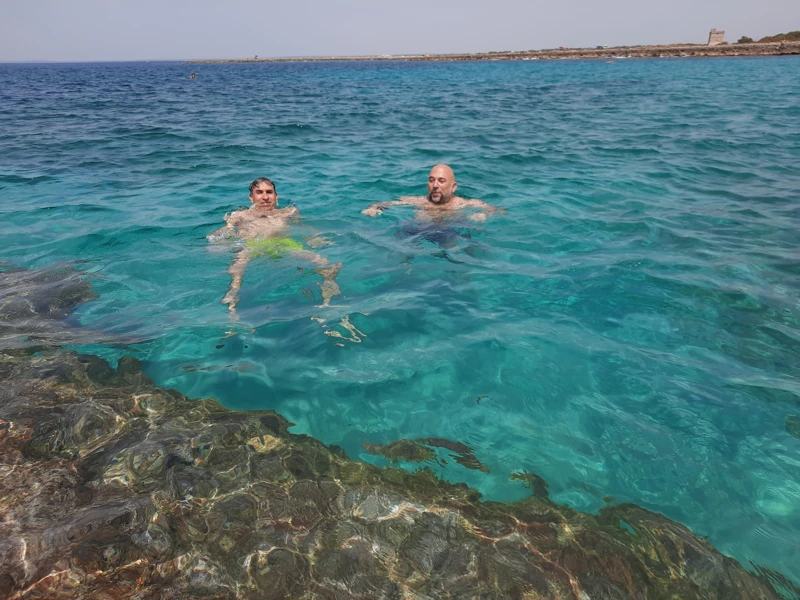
(0, 57, 800, 583)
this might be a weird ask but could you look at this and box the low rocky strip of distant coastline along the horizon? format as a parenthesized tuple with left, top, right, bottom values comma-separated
(187, 41, 800, 65)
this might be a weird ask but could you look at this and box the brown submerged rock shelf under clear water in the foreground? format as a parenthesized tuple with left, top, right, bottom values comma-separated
(0, 350, 778, 600)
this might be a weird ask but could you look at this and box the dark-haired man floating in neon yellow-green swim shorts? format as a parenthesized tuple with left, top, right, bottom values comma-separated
(207, 177, 342, 319)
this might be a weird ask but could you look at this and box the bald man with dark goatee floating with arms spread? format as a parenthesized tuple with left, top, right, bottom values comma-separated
(361, 165, 498, 222)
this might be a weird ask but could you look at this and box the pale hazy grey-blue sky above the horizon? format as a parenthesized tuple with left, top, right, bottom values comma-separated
(0, 0, 800, 62)
